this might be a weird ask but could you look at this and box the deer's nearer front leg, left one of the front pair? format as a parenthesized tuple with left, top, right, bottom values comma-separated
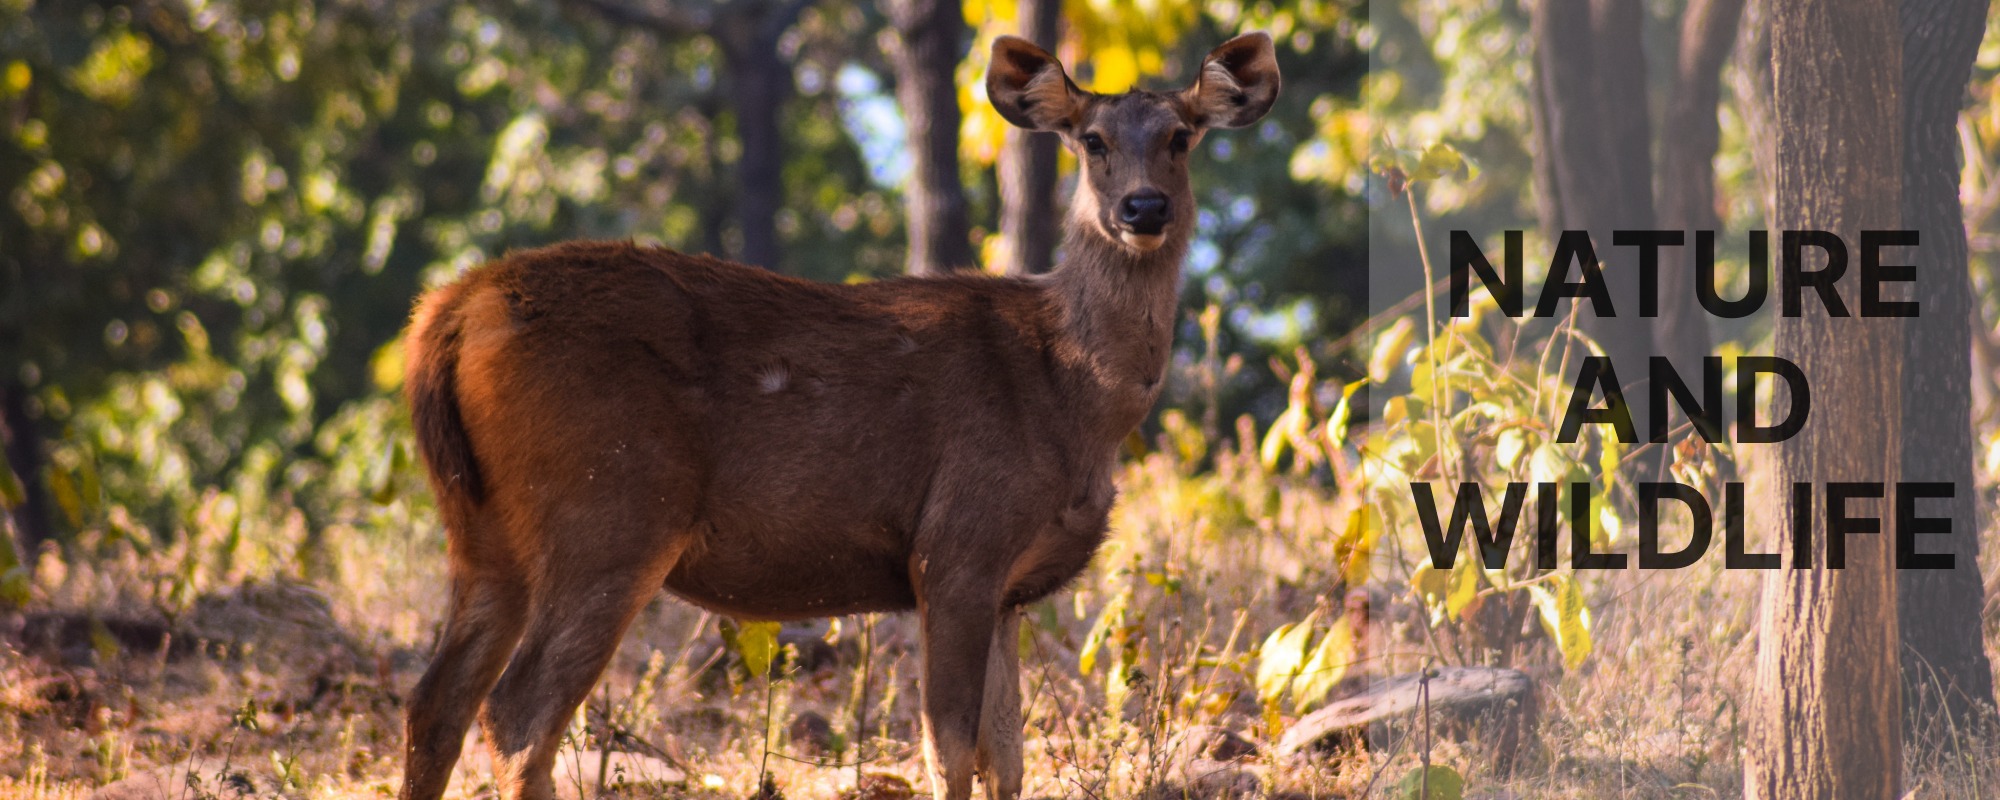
(918, 576, 1000, 800)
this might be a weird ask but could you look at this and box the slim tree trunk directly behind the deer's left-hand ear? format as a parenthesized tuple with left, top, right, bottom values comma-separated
(1000, 0, 1062, 276)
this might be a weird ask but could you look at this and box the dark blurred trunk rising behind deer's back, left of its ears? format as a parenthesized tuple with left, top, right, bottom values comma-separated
(886, 0, 976, 274)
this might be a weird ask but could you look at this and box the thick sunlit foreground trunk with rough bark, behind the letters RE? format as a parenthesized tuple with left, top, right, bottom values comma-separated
(1744, 0, 1902, 800)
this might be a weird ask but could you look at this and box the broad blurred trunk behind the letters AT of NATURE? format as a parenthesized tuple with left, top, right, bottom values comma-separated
(1532, 0, 1664, 466)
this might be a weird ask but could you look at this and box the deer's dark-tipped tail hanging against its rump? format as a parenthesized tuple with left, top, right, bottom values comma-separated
(402, 282, 486, 510)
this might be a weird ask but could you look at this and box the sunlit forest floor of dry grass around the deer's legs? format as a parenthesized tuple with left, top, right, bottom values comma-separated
(0, 444, 2000, 800)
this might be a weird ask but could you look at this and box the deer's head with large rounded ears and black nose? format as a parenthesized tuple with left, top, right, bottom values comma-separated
(986, 32, 1280, 252)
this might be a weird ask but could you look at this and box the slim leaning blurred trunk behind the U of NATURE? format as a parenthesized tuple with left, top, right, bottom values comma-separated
(1652, 0, 1744, 374)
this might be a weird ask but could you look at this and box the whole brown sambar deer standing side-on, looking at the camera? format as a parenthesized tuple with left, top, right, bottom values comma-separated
(402, 34, 1280, 800)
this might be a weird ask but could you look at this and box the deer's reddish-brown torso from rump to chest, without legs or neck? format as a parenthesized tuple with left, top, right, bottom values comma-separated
(410, 242, 1108, 618)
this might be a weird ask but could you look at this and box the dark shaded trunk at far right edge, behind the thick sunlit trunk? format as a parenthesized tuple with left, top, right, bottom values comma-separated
(1898, 0, 1994, 732)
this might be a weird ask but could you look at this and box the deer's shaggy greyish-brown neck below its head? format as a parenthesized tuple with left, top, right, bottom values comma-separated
(1048, 220, 1188, 440)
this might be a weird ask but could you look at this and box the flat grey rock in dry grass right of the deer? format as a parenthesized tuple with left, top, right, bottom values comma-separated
(1276, 666, 1536, 772)
